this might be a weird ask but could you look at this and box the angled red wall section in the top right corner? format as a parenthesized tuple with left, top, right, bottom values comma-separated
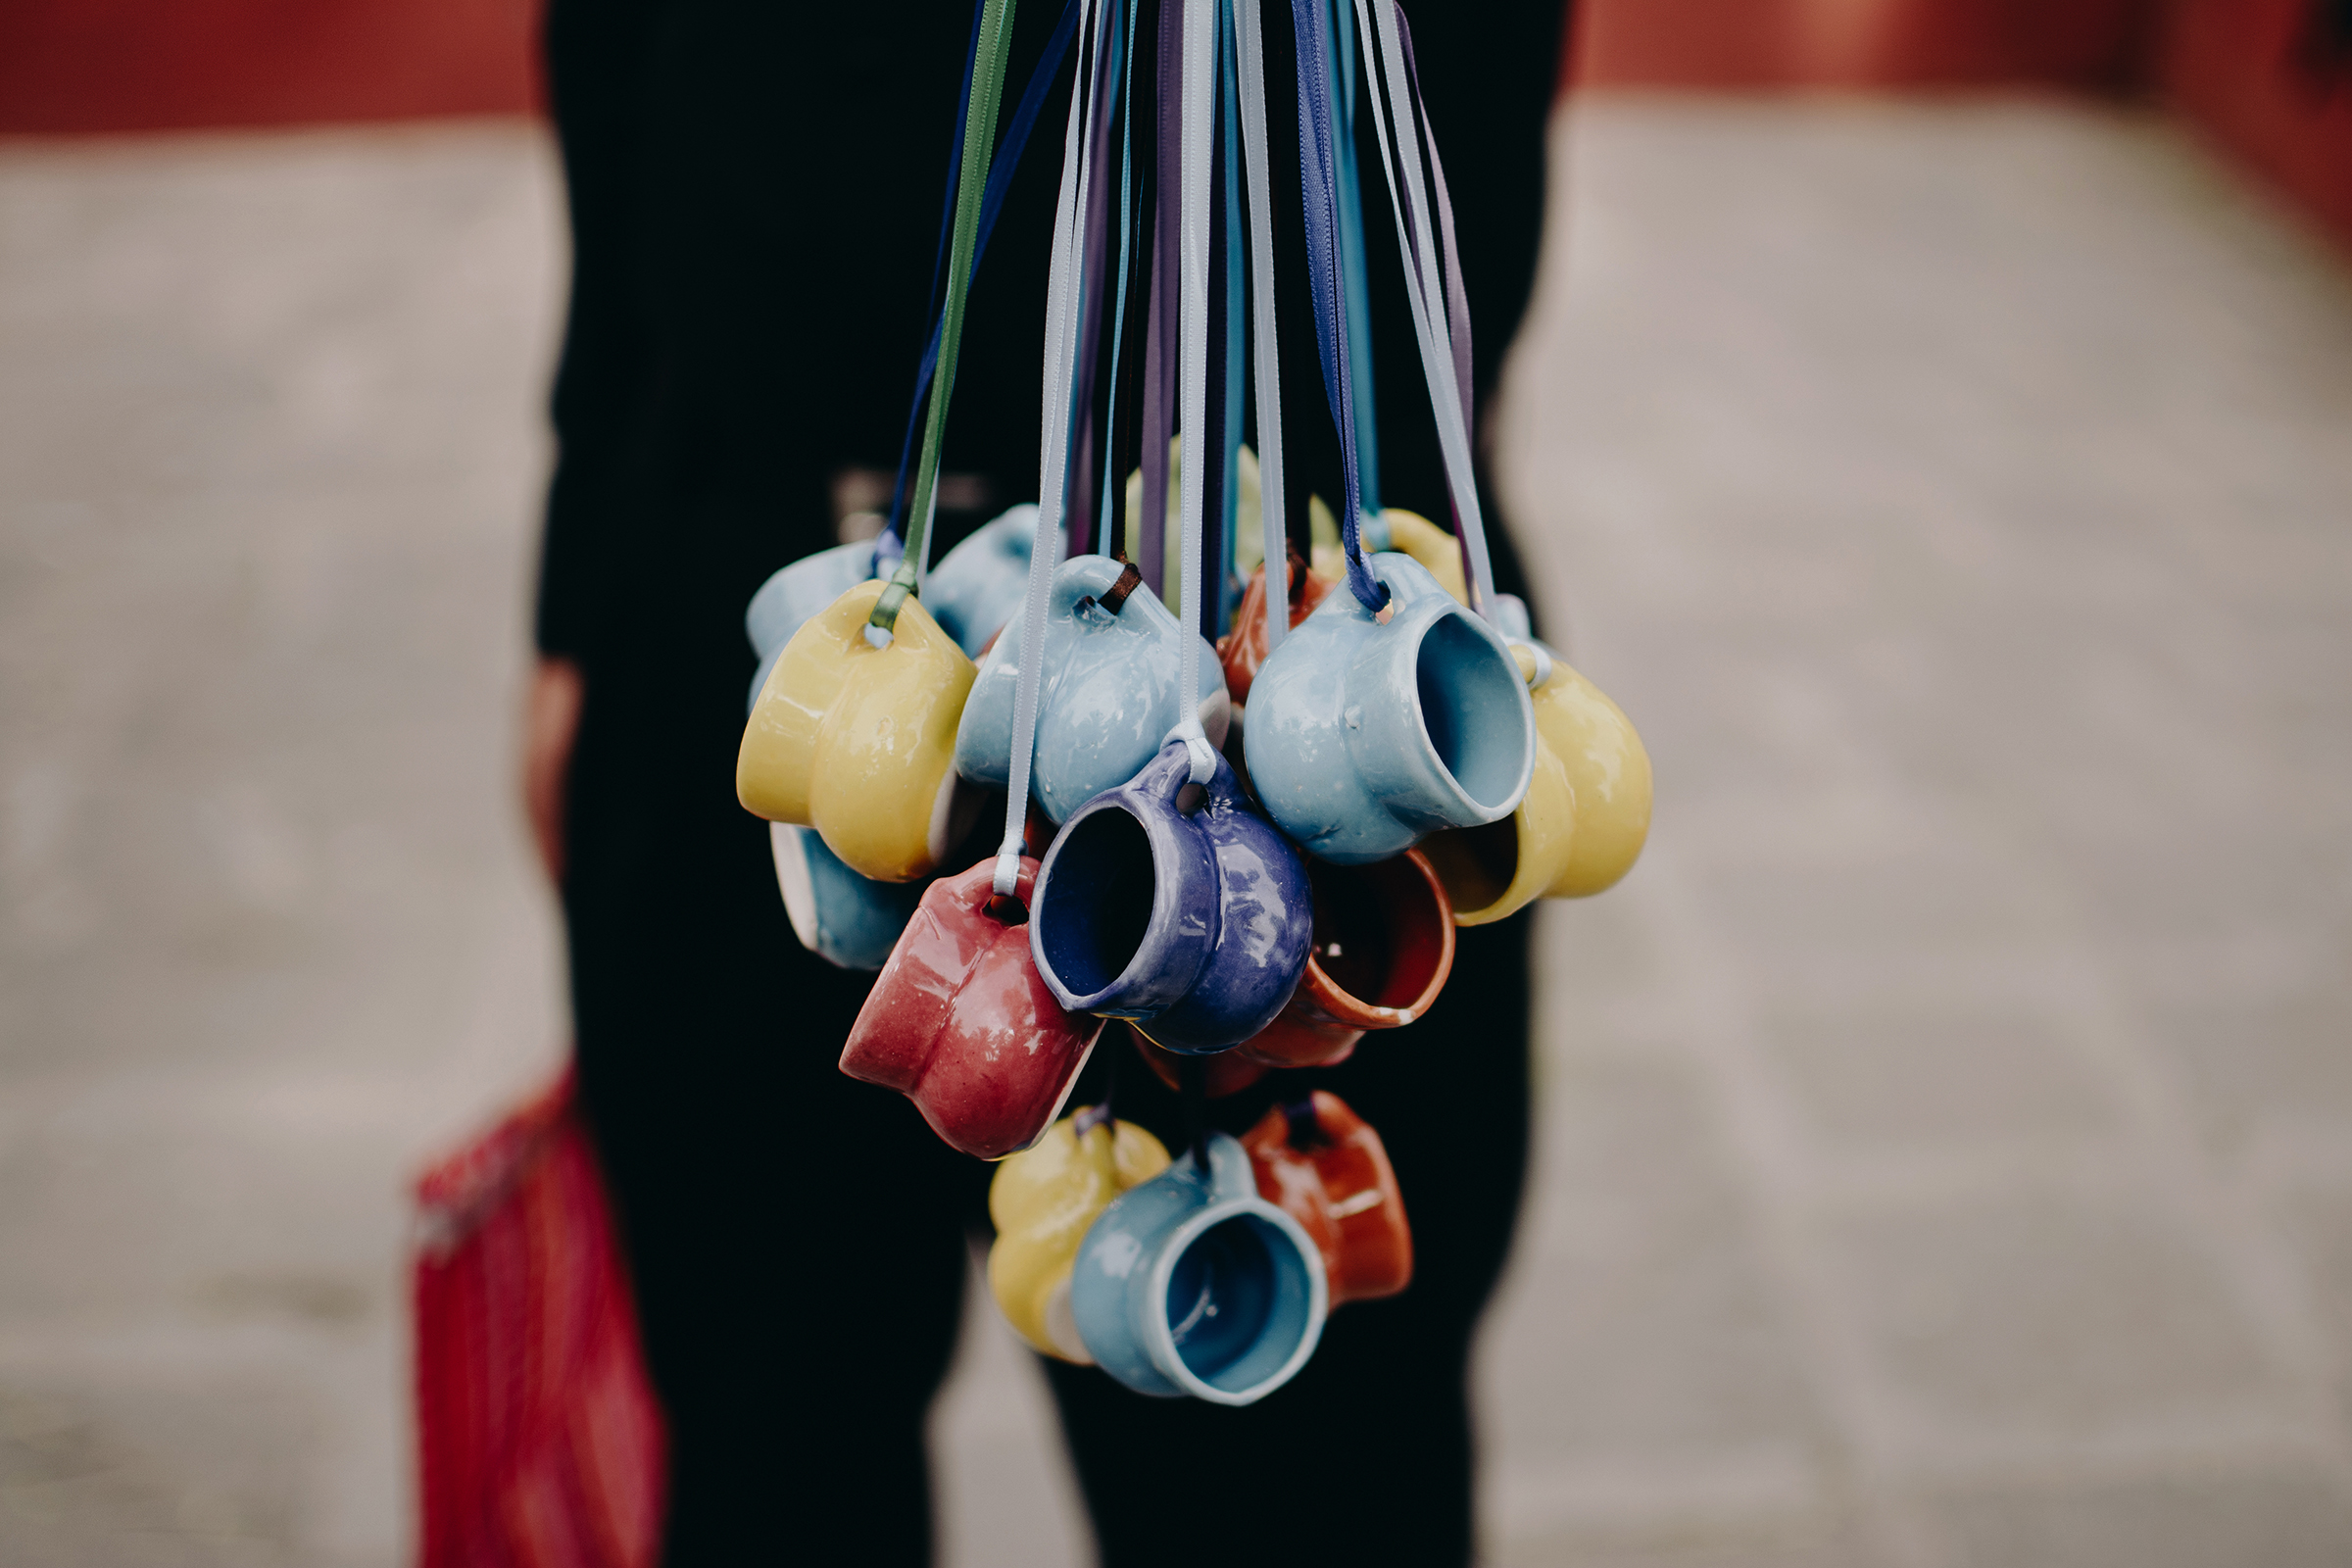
(2154, 0, 2352, 244)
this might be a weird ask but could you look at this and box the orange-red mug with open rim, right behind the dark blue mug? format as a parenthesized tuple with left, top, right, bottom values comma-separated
(1211, 851, 1453, 1071)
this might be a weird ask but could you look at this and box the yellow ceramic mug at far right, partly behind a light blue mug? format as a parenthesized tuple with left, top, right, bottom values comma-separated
(1423, 644, 1651, 926)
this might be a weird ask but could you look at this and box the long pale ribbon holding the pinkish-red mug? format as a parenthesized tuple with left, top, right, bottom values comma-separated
(993, 0, 1101, 898)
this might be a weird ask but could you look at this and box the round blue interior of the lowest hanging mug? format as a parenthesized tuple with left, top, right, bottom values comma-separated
(1164, 1213, 1312, 1394)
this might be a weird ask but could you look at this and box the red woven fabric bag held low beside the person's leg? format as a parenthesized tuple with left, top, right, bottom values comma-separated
(414, 1069, 668, 1568)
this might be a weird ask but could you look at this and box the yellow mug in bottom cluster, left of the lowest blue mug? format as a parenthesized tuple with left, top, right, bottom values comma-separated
(988, 1107, 1169, 1363)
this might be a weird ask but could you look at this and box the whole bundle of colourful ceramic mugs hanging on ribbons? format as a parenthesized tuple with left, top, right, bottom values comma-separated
(736, 0, 1651, 1403)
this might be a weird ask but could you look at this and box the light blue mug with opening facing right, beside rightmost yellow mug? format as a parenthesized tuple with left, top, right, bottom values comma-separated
(1242, 555, 1536, 865)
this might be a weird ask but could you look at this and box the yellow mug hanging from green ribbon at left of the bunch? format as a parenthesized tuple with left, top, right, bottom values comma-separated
(736, 581, 976, 882)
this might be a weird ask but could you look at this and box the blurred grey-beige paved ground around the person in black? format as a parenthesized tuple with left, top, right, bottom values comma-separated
(0, 101, 2352, 1568)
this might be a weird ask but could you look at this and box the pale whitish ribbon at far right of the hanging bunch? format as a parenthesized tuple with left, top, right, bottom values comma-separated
(1354, 0, 1495, 620)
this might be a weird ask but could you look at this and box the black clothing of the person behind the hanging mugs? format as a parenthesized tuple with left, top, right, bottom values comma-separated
(539, 0, 1559, 1566)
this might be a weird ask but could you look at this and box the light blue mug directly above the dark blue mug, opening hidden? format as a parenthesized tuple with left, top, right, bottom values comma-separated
(959, 555, 1233, 823)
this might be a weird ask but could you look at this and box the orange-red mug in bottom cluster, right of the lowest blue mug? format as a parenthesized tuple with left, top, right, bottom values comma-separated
(1242, 1089, 1413, 1309)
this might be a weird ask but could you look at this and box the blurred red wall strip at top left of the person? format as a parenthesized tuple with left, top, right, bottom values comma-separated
(0, 0, 533, 131)
